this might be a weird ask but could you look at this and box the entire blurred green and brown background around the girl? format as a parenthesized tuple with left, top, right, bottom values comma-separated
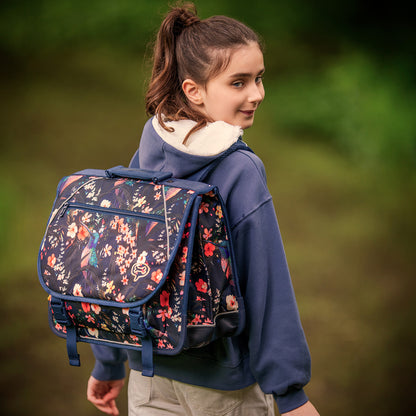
(0, 0, 416, 416)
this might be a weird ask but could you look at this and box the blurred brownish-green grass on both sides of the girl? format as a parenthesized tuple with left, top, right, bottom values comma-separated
(0, 50, 416, 416)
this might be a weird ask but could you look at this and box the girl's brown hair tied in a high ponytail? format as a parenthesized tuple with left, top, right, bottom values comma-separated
(146, 3, 262, 142)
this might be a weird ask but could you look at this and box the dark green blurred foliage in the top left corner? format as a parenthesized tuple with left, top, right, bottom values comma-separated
(0, 0, 166, 53)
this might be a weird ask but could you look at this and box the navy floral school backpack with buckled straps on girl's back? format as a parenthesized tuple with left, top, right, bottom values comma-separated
(38, 141, 249, 376)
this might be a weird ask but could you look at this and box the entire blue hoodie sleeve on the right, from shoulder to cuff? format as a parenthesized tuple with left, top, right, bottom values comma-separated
(213, 152, 310, 413)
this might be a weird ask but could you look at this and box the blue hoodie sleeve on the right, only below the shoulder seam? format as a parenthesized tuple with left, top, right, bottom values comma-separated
(233, 200, 310, 413)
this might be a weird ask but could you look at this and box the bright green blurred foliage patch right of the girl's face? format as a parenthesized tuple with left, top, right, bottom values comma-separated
(267, 53, 416, 172)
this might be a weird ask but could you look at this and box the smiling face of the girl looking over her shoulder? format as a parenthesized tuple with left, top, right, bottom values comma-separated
(199, 42, 264, 129)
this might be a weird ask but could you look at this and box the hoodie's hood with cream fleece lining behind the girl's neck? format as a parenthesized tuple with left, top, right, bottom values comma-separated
(136, 117, 242, 178)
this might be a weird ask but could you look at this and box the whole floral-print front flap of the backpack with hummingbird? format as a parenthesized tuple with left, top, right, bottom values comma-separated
(40, 176, 193, 302)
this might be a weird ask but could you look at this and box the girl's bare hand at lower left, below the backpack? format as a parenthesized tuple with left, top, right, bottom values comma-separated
(87, 376, 124, 416)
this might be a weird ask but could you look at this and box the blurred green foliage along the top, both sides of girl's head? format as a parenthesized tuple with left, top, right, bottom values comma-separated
(0, 0, 416, 174)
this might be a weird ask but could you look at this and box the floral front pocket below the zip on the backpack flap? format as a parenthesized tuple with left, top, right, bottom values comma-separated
(41, 203, 167, 302)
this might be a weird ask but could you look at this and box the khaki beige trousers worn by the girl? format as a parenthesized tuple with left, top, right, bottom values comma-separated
(128, 370, 275, 416)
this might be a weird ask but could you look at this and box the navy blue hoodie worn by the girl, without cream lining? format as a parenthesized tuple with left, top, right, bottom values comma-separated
(92, 119, 310, 413)
